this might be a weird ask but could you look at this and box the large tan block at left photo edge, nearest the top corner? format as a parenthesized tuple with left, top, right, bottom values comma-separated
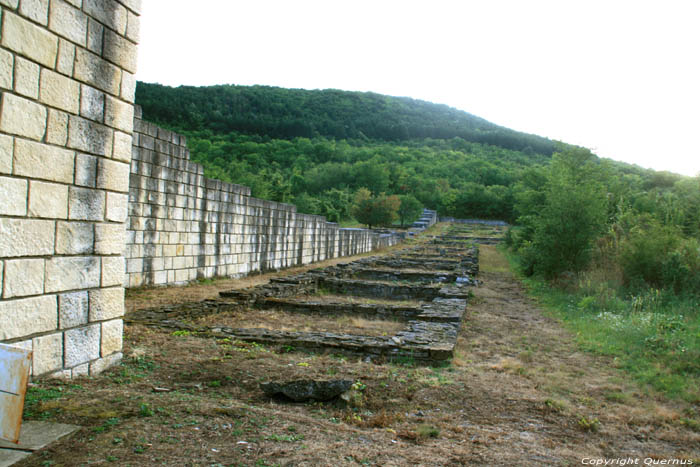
(2, 11, 58, 68)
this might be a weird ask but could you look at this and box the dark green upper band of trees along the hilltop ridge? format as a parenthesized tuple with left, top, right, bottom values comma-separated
(136, 83, 555, 155)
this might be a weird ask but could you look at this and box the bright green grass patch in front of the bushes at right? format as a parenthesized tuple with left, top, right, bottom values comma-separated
(509, 249, 700, 403)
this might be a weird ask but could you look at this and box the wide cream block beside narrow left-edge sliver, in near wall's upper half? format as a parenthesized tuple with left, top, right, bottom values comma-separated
(14, 138, 75, 183)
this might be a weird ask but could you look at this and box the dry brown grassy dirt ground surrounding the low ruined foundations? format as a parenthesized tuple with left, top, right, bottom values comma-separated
(13, 246, 700, 467)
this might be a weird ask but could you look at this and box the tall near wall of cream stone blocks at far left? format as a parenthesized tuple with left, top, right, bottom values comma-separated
(0, 0, 141, 377)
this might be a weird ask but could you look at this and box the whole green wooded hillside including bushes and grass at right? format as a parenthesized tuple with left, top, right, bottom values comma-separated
(136, 83, 700, 402)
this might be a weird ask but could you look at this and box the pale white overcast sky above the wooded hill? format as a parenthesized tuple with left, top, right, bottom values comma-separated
(137, 0, 700, 176)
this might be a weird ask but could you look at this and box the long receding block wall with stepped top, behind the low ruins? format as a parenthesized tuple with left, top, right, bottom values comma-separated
(125, 111, 400, 287)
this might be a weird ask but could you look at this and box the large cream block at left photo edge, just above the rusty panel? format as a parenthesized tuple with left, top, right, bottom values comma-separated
(0, 295, 58, 340)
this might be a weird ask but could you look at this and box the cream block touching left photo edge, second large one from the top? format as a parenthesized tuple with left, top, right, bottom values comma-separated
(0, 93, 47, 140)
